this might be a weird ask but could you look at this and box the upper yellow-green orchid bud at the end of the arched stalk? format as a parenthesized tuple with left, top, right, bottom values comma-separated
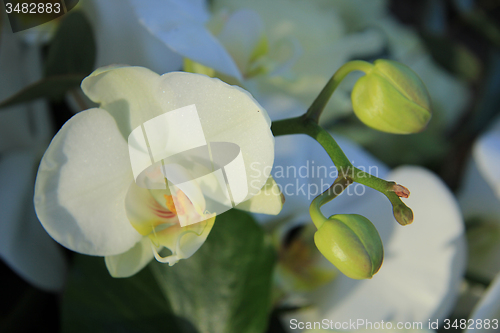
(351, 59, 432, 134)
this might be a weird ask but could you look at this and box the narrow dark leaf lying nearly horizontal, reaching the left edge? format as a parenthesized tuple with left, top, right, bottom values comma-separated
(0, 74, 86, 108)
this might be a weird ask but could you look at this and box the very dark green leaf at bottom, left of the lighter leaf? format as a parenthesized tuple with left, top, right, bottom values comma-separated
(62, 255, 189, 333)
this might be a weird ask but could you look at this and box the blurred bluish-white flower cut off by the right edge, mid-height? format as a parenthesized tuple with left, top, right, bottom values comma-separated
(459, 119, 500, 280)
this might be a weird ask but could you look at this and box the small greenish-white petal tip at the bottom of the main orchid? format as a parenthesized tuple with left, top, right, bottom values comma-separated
(105, 237, 154, 278)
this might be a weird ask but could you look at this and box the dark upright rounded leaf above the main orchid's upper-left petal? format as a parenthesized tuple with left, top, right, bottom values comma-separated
(44, 10, 96, 77)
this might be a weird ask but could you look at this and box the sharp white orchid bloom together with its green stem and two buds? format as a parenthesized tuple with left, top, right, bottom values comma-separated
(35, 45, 430, 279)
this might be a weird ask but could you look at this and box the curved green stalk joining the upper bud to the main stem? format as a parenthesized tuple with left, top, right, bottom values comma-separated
(305, 60, 373, 124)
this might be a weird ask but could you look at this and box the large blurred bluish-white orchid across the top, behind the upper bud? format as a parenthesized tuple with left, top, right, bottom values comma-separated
(126, 0, 469, 125)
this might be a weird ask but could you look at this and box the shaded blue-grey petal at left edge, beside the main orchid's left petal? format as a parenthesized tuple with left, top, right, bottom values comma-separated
(0, 152, 66, 291)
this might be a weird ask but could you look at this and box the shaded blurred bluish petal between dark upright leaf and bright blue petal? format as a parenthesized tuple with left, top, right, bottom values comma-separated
(80, 0, 182, 73)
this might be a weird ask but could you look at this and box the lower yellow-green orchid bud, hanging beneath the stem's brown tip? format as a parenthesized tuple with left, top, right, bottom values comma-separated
(314, 214, 384, 280)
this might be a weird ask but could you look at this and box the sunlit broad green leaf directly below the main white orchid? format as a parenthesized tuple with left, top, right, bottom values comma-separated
(151, 209, 275, 333)
